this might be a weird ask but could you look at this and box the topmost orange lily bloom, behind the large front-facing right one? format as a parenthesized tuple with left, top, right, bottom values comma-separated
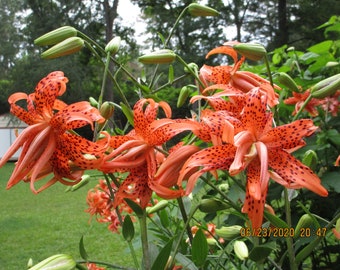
(200, 42, 280, 107)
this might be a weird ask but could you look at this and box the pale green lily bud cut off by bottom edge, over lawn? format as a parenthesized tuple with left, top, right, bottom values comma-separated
(30, 254, 76, 270)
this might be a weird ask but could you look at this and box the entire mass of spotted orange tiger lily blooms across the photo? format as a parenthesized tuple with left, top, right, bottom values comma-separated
(0, 42, 338, 231)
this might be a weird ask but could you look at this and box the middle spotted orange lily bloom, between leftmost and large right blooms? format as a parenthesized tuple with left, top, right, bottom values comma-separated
(100, 99, 201, 208)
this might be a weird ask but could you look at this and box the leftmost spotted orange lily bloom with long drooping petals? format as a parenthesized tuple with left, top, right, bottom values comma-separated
(0, 71, 108, 193)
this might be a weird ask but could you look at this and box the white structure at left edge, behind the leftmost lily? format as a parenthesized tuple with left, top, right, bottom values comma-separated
(0, 114, 27, 161)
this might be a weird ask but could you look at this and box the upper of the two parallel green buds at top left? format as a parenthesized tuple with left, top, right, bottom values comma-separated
(34, 26, 77, 46)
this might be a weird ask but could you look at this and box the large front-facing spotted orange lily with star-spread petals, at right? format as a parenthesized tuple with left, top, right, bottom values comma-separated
(179, 88, 328, 228)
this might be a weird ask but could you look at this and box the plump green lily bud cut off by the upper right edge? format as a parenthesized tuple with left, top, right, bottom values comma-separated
(310, 73, 340, 99)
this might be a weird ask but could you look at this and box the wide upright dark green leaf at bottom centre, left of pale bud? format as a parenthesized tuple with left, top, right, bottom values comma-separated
(191, 229, 209, 267)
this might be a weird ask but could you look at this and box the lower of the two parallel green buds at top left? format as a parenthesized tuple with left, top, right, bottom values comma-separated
(41, 37, 84, 59)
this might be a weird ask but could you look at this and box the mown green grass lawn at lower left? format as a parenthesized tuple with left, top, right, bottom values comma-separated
(0, 163, 133, 270)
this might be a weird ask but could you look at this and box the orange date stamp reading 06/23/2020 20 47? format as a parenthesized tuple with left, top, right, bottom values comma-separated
(240, 227, 327, 238)
